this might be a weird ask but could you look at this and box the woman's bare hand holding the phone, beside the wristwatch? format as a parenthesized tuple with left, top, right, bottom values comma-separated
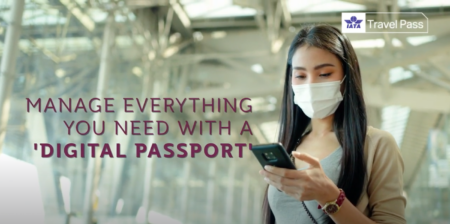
(259, 152, 339, 206)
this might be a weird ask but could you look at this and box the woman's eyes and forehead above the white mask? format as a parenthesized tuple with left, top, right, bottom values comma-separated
(292, 46, 344, 85)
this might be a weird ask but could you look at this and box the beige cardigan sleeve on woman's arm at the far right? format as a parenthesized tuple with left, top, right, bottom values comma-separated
(367, 131, 406, 224)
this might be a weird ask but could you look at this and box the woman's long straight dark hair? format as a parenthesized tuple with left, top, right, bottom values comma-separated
(263, 25, 367, 224)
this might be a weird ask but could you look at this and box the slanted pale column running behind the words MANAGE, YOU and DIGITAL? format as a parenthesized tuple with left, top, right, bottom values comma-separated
(83, 13, 114, 224)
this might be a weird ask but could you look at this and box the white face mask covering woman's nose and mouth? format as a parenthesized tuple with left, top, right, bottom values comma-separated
(292, 77, 345, 119)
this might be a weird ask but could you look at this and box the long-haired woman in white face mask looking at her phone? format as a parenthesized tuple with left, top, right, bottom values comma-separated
(260, 25, 406, 224)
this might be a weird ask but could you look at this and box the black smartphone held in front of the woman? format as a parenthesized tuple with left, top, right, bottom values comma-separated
(252, 143, 296, 169)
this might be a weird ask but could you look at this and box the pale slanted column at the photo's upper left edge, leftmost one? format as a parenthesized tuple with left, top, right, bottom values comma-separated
(0, 0, 25, 152)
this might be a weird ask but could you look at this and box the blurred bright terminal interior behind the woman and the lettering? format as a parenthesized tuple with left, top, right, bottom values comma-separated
(0, 0, 450, 224)
